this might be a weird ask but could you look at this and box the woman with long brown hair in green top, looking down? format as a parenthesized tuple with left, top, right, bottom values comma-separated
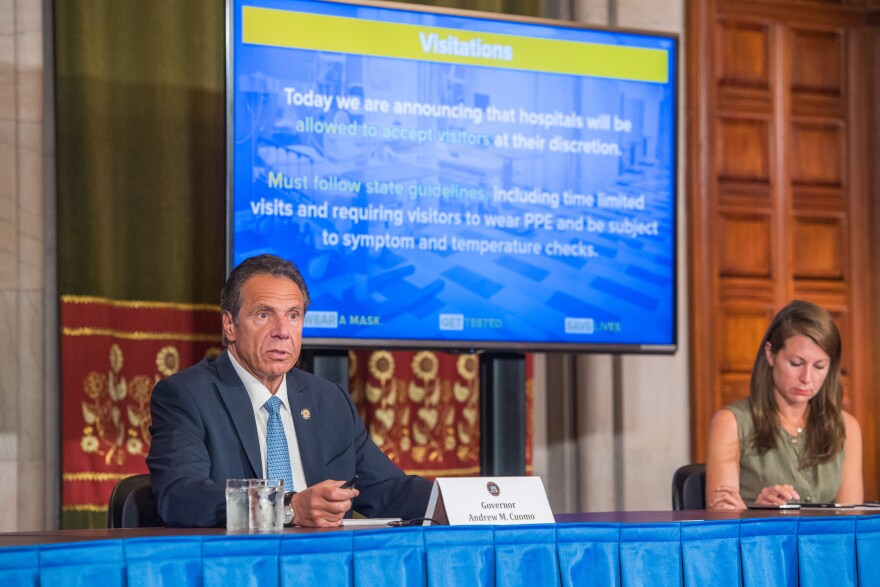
(706, 301, 864, 509)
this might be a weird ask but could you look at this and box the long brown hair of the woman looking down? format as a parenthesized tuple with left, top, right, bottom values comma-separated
(749, 300, 846, 467)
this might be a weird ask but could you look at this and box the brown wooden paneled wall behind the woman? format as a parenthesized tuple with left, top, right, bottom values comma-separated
(686, 0, 880, 499)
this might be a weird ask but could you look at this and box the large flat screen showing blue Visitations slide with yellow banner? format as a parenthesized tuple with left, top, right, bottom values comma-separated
(227, 0, 678, 353)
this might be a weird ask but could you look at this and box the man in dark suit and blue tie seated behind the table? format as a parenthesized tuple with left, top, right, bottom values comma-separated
(147, 255, 431, 527)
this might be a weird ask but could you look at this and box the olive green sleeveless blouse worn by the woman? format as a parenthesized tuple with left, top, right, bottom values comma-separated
(727, 399, 843, 503)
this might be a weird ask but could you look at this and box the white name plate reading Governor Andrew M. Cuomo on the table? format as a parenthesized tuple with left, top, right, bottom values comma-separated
(424, 477, 556, 526)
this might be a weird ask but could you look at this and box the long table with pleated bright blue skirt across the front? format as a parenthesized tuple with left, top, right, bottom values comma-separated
(0, 510, 880, 587)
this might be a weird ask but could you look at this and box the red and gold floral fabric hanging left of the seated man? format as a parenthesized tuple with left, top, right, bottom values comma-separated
(61, 296, 221, 528)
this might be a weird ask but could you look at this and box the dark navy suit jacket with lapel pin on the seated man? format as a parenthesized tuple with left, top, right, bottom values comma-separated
(147, 351, 431, 527)
